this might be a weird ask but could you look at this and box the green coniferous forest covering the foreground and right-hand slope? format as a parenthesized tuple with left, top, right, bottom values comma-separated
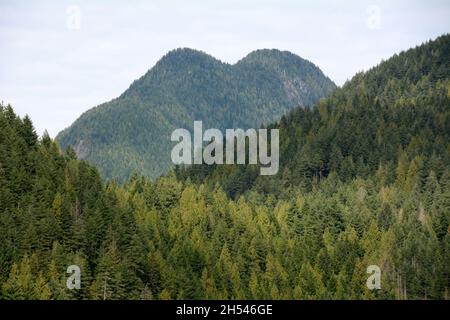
(0, 35, 450, 300)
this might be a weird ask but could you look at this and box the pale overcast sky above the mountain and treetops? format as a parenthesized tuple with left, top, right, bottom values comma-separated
(0, 0, 450, 137)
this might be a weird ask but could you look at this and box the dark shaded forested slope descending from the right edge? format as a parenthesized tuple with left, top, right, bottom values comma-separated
(177, 35, 450, 198)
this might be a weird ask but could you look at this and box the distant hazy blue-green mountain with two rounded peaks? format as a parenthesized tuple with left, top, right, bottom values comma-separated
(57, 49, 335, 181)
